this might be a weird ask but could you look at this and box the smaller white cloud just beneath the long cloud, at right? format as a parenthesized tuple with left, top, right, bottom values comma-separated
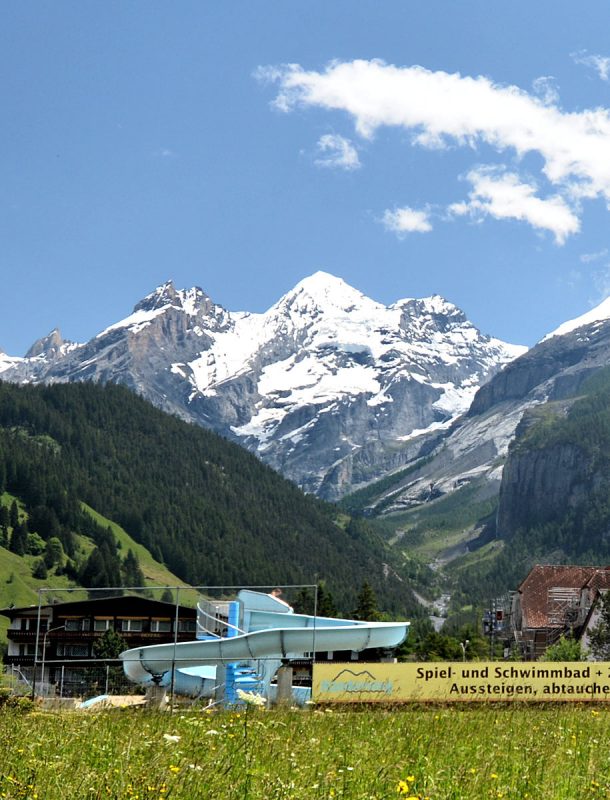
(449, 167, 580, 244)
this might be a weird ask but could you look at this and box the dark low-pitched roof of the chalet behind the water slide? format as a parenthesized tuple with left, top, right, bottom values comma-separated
(0, 594, 196, 619)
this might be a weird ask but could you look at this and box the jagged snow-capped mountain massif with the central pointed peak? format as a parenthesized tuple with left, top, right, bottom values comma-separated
(0, 272, 525, 498)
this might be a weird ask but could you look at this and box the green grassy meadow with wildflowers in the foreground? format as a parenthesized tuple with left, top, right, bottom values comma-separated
(0, 705, 610, 800)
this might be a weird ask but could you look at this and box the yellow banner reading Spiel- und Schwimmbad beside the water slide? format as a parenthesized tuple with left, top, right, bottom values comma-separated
(312, 661, 610, 703)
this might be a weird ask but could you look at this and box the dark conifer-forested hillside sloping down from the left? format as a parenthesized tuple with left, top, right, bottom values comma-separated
(0, 383, 413, 612)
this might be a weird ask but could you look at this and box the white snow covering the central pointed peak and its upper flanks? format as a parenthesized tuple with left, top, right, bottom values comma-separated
(179, 272, 524, 450)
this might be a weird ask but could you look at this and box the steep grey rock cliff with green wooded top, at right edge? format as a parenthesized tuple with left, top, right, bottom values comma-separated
(497, 367, 610, 554)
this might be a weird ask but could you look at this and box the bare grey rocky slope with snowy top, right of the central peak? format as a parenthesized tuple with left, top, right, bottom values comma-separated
(356, 299, 610, 520)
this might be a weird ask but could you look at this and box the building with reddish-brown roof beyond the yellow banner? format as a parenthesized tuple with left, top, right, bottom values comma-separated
(510, 564, 610, 660)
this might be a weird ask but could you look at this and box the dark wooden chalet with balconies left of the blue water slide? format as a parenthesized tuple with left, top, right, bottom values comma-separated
(0, 595, 197, 695)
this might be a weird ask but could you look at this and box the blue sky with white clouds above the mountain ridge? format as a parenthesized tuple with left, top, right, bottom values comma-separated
(0, 0, 610, 355)
